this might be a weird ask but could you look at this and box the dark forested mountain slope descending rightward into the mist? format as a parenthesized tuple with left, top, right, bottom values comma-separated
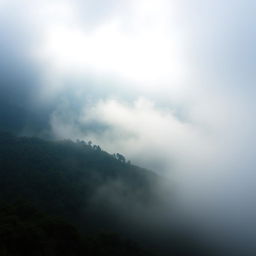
(0, 132, 213, 256)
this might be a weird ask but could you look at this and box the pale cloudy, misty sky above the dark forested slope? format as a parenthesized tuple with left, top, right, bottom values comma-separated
(0, 0, 256, 252)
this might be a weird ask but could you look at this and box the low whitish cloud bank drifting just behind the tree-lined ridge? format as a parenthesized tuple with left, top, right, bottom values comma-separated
(51, 94, 252, 204)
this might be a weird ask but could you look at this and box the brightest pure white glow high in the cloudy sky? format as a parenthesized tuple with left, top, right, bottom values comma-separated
(39, 1, 188, 89)
